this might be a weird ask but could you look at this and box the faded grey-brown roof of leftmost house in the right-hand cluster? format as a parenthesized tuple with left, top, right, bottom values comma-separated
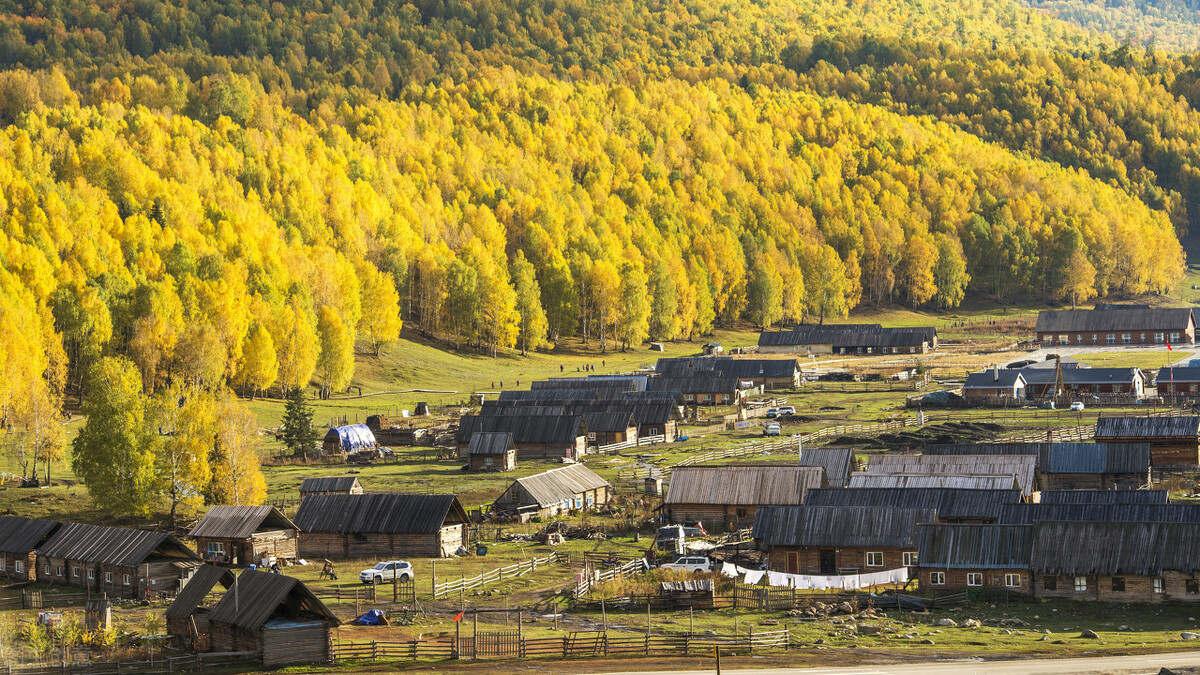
(664, 464, 824, 506)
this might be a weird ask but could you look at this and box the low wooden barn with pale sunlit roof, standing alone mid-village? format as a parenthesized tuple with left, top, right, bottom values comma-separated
(492, 464, 612, 519)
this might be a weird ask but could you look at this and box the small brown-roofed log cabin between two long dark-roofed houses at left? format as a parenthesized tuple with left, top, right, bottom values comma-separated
(187, 504, 300, 566)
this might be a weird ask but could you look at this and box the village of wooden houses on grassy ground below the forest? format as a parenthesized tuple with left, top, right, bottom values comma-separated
(0, 305, 1200, 675)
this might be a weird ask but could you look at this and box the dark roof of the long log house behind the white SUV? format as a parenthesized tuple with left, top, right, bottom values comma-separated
(293, 494, 467, 534)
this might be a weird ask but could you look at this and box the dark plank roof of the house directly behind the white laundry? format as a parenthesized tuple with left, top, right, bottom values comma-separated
(751, 506, 937, 549)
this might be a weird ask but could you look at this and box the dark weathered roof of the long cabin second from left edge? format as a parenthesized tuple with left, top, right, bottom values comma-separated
(37, 522, 200, 567)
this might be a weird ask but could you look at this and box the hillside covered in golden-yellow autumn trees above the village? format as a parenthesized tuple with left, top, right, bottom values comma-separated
(0, 0, 1200, 428)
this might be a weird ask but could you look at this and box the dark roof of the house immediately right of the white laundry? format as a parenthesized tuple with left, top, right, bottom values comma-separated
(917, 525, 1033, 569)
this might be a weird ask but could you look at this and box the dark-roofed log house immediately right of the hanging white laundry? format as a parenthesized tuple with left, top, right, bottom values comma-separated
(917, 524, 1033, 595)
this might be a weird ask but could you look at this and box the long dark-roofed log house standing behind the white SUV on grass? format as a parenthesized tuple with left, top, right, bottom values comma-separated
(293, 494, 468, 558)
